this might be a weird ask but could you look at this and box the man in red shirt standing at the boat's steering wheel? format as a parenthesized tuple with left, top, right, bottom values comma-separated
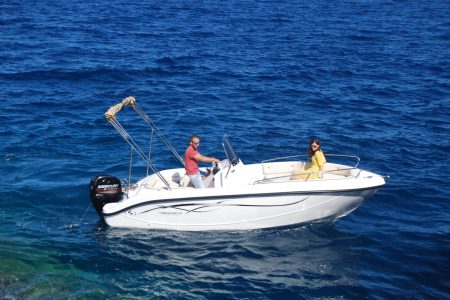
(184, 135, 219, 188)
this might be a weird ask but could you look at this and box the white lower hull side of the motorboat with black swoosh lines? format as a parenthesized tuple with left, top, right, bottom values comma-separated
(103, 182, 377, 231)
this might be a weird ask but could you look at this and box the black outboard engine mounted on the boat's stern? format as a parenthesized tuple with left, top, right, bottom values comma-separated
(90, 175, 122, 217)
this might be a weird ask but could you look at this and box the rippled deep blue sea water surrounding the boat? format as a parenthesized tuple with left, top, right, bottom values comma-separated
(0, 0, 450, 299)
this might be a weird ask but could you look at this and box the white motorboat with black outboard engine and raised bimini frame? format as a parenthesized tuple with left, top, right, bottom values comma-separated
(90, 97, 386, 231)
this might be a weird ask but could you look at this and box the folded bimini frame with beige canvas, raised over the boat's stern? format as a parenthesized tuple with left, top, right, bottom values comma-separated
(105, 96, 184, 189)
